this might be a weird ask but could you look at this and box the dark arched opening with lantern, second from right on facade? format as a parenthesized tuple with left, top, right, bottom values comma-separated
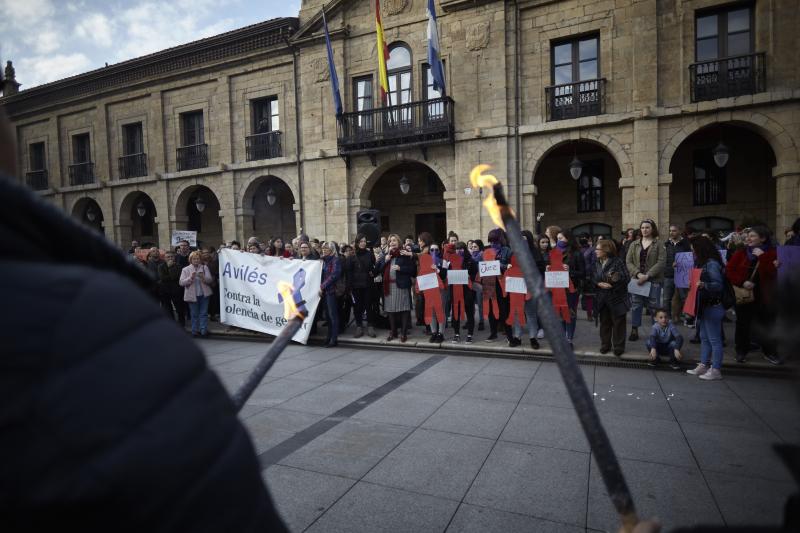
(531, 141, 622, 238)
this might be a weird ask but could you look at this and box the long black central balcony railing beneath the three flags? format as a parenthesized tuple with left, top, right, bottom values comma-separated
(338, 96, 455, 155)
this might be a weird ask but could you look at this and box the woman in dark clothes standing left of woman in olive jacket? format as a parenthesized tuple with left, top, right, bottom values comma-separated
(592, 239, 630, 356)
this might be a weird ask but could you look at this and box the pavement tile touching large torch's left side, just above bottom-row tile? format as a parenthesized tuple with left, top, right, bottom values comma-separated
(500, 404, 589, 453)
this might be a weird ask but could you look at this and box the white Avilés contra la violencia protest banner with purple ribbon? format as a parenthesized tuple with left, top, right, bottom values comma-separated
(219, 248, 322, 344)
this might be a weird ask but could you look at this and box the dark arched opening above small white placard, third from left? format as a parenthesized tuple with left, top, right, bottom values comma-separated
(175, 185, 223, 247)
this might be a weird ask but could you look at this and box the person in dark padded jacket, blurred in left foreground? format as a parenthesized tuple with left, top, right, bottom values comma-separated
(0, 172, 286, 533)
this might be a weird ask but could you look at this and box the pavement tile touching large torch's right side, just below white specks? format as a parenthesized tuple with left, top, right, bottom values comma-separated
(600, 412, 696, 466)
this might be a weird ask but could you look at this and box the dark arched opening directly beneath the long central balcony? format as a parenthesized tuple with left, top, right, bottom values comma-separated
(369, 161, 447, 242)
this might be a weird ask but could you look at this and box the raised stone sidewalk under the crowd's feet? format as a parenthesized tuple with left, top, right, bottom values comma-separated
(197, 311, 800, 375)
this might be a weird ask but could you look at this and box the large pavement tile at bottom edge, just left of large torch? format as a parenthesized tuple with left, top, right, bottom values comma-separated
(464, 441, 589, 527)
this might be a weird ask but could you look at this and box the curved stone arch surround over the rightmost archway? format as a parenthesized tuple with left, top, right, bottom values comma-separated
(658, 111, 798, 176)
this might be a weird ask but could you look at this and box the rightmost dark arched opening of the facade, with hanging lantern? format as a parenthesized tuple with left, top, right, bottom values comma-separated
(669, 123, 776, 231)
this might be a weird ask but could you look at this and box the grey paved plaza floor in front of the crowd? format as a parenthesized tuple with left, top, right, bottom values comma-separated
(199, 339, 800, 533)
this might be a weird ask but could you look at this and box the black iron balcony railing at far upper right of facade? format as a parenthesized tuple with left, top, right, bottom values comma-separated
(689, 52, 767, 102)
